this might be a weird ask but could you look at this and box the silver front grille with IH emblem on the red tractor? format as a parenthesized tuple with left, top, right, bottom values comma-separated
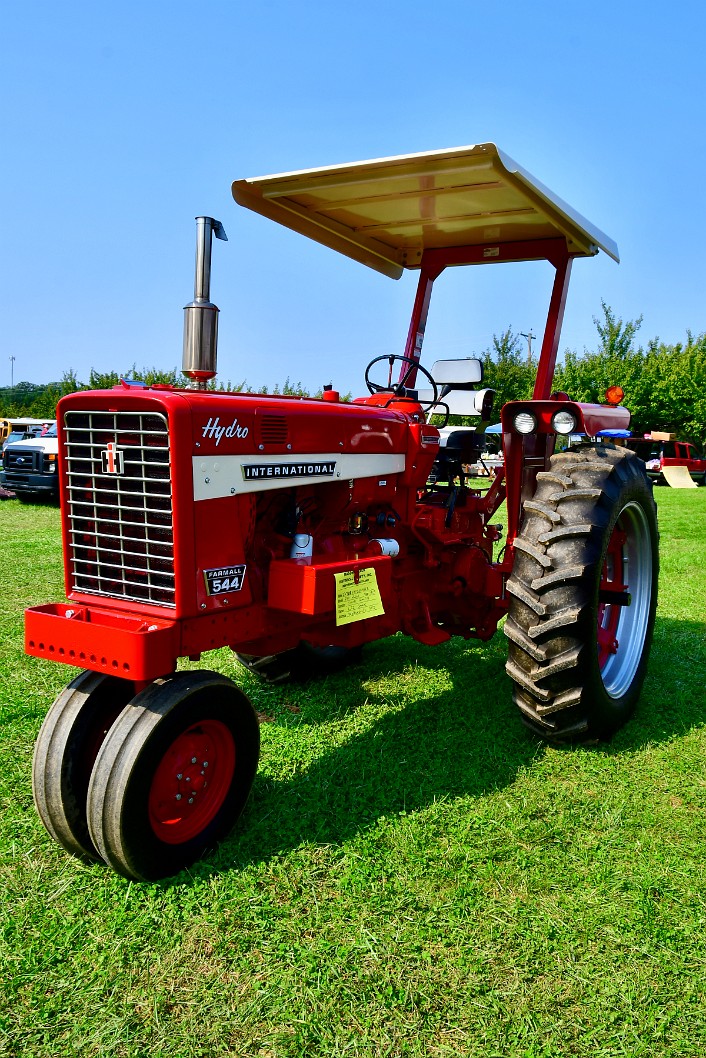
(65, 411, 176, 607)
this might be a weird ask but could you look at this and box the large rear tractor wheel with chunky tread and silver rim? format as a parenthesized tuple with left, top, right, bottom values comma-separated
(505, 444, 658, 743)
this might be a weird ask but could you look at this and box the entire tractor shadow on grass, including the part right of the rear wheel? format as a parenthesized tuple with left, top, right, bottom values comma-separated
(190, 619, 706, 881)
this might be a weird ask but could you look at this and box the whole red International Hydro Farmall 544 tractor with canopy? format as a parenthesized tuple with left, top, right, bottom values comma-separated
(25, 144, 658, 879)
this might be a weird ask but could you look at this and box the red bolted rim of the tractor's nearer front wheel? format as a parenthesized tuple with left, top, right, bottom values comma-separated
(148, 719, 235, 845)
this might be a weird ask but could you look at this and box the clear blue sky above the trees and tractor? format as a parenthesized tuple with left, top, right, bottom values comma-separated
(0, 0, 706, 394)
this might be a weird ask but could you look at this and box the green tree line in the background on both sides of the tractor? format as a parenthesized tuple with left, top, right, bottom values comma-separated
(0, 302, 706, 448)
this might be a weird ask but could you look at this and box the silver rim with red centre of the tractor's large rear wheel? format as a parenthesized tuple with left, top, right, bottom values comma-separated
(597, 503, 653, 698)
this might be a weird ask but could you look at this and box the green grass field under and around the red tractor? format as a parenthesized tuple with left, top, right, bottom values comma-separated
(0, 489, 706, 1058)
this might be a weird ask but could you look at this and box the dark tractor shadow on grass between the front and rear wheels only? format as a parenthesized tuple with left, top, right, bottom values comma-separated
(212, 639, 537, 871)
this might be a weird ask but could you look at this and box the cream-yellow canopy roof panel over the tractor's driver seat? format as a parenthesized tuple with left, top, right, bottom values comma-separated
(233, 143, 619, 279)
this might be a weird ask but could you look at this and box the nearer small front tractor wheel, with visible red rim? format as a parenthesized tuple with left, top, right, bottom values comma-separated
(88, 670, 259, 880)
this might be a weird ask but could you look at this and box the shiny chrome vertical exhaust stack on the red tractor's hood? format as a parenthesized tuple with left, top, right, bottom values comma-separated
(181, 217, 228, 389)
